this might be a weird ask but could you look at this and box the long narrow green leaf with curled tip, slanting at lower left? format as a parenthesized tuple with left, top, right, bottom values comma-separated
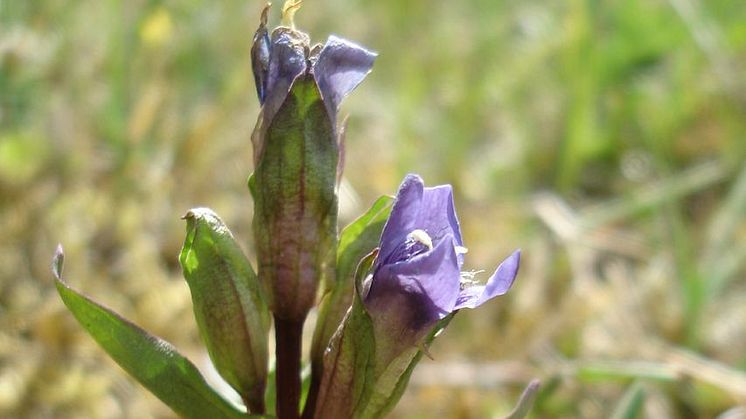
(52, 246, 248, 419)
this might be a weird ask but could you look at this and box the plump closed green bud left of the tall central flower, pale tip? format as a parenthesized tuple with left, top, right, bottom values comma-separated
(179, 208, 270, 413)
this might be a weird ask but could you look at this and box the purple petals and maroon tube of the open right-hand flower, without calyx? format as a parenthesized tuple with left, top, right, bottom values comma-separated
(364, 175, 520, 355)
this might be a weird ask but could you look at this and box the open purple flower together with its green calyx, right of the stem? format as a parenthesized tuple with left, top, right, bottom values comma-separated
(315, 175, 520, 418)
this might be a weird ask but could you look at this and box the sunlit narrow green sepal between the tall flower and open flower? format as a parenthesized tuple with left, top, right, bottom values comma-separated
(311, 196, 394, 371)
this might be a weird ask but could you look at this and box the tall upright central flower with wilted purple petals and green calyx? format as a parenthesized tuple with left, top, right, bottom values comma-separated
(249, 8, 375, 321)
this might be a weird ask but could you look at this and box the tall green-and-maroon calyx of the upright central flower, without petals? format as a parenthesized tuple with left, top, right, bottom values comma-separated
(250, 74, 339, 321)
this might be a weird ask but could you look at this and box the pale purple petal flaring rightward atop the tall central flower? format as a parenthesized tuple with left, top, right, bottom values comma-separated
(313, 35, 376, 120)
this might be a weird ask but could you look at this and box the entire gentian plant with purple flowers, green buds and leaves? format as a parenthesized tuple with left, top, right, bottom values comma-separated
(53, 0, 536, 419)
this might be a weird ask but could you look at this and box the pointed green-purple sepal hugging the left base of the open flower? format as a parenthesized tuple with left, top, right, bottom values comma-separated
(313, 251, 377, 418)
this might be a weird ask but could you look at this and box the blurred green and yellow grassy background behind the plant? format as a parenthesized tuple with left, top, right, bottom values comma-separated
(0, 0, 746, 418)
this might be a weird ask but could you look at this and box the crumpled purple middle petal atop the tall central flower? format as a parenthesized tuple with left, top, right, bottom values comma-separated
(263, 27, 309, 125)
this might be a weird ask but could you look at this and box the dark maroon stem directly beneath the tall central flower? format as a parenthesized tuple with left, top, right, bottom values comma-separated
(275, 316, 303, 419)
